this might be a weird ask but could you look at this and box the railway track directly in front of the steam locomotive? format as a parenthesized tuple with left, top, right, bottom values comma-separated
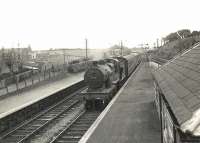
(50, 111, 100, 143)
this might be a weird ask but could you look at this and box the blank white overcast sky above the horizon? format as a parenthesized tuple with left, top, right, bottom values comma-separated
(0, 0, 200, 50)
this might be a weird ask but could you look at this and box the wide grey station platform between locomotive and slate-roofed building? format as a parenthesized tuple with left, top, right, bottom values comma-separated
(79, 63, 161, 143)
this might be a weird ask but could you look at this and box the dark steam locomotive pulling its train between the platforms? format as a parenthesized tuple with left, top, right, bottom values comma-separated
(81, 54, 141, 110)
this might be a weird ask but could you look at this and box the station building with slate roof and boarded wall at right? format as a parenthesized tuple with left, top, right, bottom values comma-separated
(154, 43, 200, 143)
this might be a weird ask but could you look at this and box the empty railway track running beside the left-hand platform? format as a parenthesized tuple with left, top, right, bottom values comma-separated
(0, 87, 85, 143)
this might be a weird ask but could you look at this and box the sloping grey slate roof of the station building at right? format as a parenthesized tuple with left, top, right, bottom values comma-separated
(154, 44, 200, 124)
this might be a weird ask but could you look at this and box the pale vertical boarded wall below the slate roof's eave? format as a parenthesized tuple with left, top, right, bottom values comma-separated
(160, 98, 175, 143)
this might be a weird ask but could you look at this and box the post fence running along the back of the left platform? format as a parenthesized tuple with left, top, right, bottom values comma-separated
(0, 64, 68, 96)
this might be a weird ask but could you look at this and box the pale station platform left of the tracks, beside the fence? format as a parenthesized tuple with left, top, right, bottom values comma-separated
(0, 72, 84, 119)
